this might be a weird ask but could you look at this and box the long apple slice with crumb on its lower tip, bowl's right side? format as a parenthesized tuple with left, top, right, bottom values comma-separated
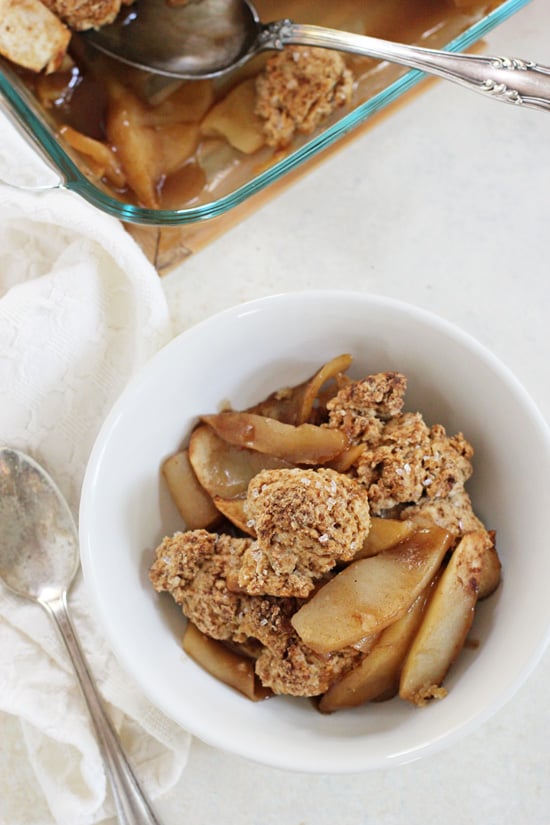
(399, 530, 493, 706)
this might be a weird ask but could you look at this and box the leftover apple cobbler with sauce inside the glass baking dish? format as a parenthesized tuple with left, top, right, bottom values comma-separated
(0, 0, 508, 210)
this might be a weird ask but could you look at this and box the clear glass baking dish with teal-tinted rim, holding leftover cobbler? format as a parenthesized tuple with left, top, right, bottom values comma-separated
(0, 0, 529, 232)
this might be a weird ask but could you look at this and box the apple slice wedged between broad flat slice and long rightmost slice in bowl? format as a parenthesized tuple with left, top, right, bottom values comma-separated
(318, 584, 432, 713)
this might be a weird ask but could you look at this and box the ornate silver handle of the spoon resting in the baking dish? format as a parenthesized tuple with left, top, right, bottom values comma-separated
(270, 20, 550, 111)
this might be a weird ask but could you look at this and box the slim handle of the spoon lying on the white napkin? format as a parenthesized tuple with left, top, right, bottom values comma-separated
(40, 594, 159, 825)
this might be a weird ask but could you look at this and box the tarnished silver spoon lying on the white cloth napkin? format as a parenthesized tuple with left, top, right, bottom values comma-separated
(0, 448, 159, 825)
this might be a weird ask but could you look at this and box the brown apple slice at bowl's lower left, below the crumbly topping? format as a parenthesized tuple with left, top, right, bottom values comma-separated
(183, 622, 272, 702)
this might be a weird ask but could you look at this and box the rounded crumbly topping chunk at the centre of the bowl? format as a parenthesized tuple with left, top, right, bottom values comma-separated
(239, 469, 370, 598)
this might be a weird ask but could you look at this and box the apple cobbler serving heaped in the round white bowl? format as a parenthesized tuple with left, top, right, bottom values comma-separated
(150, 355, 500, 712)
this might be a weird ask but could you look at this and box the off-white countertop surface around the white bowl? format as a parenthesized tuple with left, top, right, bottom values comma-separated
(143, 0, 550, 825)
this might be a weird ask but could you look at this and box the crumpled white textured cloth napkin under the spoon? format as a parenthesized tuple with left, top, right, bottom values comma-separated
(0, 113, 193, 825)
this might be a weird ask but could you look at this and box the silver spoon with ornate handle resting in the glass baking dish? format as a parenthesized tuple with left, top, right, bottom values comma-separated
(84, 0, 550, 110)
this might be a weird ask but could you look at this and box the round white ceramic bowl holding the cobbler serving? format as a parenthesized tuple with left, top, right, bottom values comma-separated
(80, 291, 550, 773)
